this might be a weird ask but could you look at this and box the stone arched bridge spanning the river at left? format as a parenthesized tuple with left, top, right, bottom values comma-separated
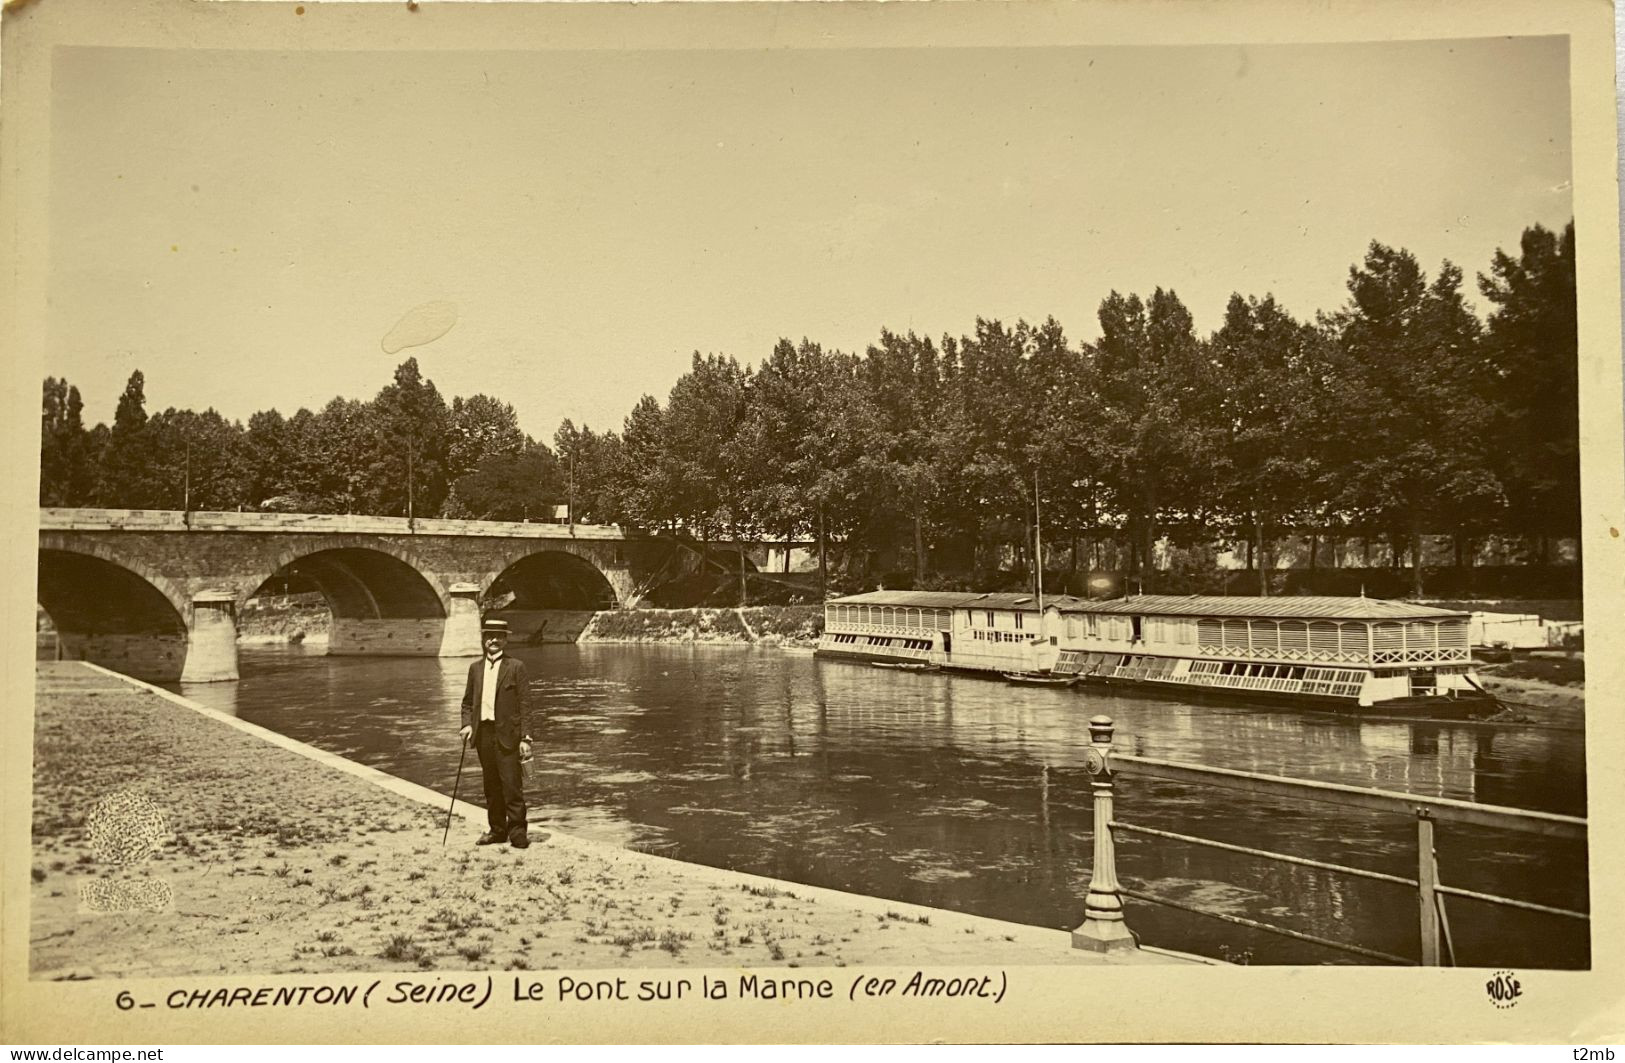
(39, 509, 756, 683)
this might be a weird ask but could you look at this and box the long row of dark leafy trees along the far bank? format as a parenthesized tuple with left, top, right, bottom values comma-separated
(41, 223, 1580, 593)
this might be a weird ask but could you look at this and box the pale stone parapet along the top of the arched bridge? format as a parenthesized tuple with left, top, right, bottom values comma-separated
(39, 507, 627, 541)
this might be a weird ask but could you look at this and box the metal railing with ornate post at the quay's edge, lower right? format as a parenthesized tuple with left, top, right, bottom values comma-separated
(1073, 717, 1591, 967)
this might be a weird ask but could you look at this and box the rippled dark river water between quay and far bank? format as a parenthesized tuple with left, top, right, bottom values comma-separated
(182, 644, 1589, 967)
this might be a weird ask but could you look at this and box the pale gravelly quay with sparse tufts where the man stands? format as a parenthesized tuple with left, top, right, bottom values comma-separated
(29, 662, 1201, 978)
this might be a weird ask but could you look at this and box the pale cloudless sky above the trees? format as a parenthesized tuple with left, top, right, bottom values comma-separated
(46, 37, 1584, 440)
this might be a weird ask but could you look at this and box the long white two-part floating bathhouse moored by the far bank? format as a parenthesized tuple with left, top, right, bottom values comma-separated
(817, 592, 1497, 717)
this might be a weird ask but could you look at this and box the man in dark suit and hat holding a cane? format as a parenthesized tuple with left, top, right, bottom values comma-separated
(462, 618, 530, 848)
